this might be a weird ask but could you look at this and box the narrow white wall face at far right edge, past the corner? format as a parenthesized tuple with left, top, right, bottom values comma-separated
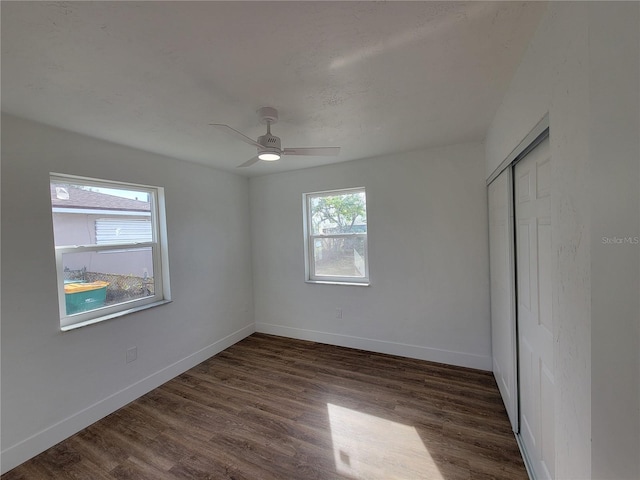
(589, 2, 640, 479)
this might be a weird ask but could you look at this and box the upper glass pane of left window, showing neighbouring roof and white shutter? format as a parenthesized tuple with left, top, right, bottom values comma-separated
(51, 180, 152, 246)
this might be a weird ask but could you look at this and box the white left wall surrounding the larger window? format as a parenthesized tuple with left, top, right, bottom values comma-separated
(2, 116, 254, 472)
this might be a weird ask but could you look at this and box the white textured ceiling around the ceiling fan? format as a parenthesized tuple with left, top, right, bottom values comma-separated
(0, 1, 545, 175)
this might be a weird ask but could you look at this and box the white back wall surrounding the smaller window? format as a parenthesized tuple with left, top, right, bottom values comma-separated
(250, 144, 491, 370)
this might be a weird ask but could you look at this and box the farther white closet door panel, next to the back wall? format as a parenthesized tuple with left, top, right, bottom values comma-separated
(488, 168, 518, 432)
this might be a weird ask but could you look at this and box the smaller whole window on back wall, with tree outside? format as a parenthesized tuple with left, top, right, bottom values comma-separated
(304, 188, 369, 285)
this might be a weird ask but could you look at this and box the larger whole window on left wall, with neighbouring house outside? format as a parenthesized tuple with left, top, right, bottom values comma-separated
(50, 175, 170, 330)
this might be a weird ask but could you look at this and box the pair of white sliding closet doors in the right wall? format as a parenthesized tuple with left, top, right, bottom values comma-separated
(488, 136, 555, 480)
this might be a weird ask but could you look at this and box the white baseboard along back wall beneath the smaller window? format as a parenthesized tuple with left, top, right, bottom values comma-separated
(256, 323, 492, 371)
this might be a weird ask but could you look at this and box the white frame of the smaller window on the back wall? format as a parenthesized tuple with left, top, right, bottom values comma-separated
(302, 187, 371, 287)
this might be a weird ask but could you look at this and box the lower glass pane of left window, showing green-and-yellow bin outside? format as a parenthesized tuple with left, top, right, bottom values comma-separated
(62, 247, 155, 315)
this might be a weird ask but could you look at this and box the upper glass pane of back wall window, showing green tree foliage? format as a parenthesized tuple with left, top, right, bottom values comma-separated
(310, 192, 367, 235)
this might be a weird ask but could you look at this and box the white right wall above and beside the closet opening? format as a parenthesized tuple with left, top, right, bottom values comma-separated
(486, 2, 640, 479)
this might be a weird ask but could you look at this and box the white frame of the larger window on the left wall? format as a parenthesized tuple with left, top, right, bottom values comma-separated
(49, 173, 171, 331)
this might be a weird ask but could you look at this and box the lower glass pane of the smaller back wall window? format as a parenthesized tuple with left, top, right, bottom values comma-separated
(312, 236, 366, 278)
